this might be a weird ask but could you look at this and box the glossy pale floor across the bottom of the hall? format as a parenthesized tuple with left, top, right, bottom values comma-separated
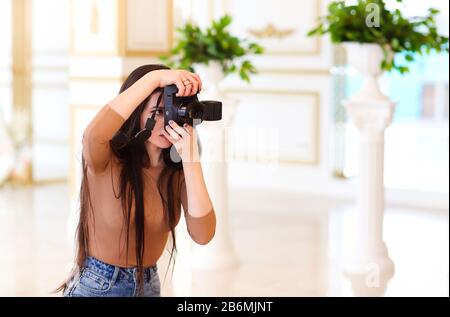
(0, 184, 449, 296)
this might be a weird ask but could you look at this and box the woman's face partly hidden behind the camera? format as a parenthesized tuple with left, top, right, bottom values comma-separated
(141, 93, 172, 149)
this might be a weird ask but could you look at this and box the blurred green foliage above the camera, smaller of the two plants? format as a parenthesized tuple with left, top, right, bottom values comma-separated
(160, 15, 263, 90)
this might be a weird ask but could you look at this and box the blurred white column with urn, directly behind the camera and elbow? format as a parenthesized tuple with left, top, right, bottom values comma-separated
(191, 63, 238, 270)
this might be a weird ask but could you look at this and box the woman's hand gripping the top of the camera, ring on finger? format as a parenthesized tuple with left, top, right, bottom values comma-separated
(149, 69, 202, 97)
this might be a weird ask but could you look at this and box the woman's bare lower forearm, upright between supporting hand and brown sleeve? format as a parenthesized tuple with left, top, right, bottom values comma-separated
(183, 162, 213, 217)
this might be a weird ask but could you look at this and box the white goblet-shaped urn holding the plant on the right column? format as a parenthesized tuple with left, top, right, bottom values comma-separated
(343, 42, 392, 102)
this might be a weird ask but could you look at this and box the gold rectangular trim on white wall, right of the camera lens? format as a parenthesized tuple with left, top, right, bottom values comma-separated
(223, 88, 322, 165)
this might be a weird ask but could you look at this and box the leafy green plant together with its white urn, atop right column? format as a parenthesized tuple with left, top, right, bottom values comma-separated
(308, 0, 448, 101)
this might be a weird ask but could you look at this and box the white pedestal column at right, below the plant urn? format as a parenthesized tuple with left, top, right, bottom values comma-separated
(344, 99, 394, 295)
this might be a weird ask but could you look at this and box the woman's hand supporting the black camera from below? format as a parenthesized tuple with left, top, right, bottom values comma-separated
(163, 120, 200, 163)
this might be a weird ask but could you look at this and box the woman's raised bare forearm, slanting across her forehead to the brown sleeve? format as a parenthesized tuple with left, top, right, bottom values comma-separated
(108, 72, 159, 120)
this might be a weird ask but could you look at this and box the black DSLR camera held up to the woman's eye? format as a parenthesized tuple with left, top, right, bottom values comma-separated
(163, 85, 222, 126)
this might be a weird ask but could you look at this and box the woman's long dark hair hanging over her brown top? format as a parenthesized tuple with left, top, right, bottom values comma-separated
(57, 65, 183, 291)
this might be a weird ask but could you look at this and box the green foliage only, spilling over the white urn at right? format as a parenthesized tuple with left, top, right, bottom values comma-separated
(308, 0, 448, 74)
